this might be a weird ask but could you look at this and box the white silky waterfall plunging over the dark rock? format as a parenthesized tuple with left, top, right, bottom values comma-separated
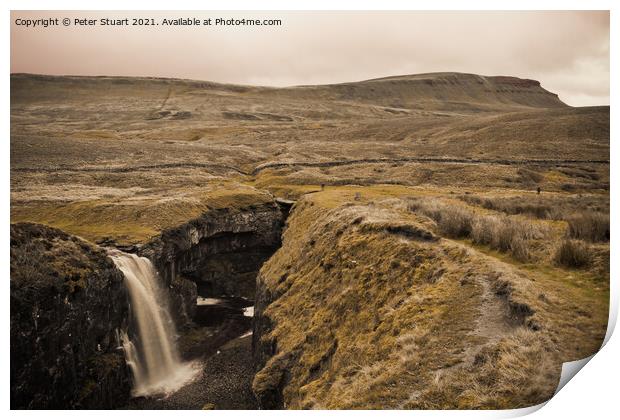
(109, 250, 200, 396)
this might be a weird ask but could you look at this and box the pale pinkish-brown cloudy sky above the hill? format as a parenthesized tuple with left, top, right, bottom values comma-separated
(11, 11, 609, 106)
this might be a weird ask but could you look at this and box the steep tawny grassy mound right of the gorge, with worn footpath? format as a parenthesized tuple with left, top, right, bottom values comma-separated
(254, 187, 609, 409)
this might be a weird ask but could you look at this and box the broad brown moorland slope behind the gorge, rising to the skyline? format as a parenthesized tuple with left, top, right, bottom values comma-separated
(11, 73, 609, 241)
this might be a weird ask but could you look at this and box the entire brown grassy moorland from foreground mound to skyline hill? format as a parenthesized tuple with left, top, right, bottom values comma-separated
(11, 73, 609, 408)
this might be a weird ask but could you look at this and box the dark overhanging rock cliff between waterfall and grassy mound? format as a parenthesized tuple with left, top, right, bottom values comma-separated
(140, 201, 283, 326)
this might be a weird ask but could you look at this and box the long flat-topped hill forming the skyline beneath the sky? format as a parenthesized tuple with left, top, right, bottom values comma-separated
(11, 73, 566, 111)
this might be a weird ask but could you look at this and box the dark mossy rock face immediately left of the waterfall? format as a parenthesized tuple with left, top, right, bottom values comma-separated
(11, 223, 131, 409)
